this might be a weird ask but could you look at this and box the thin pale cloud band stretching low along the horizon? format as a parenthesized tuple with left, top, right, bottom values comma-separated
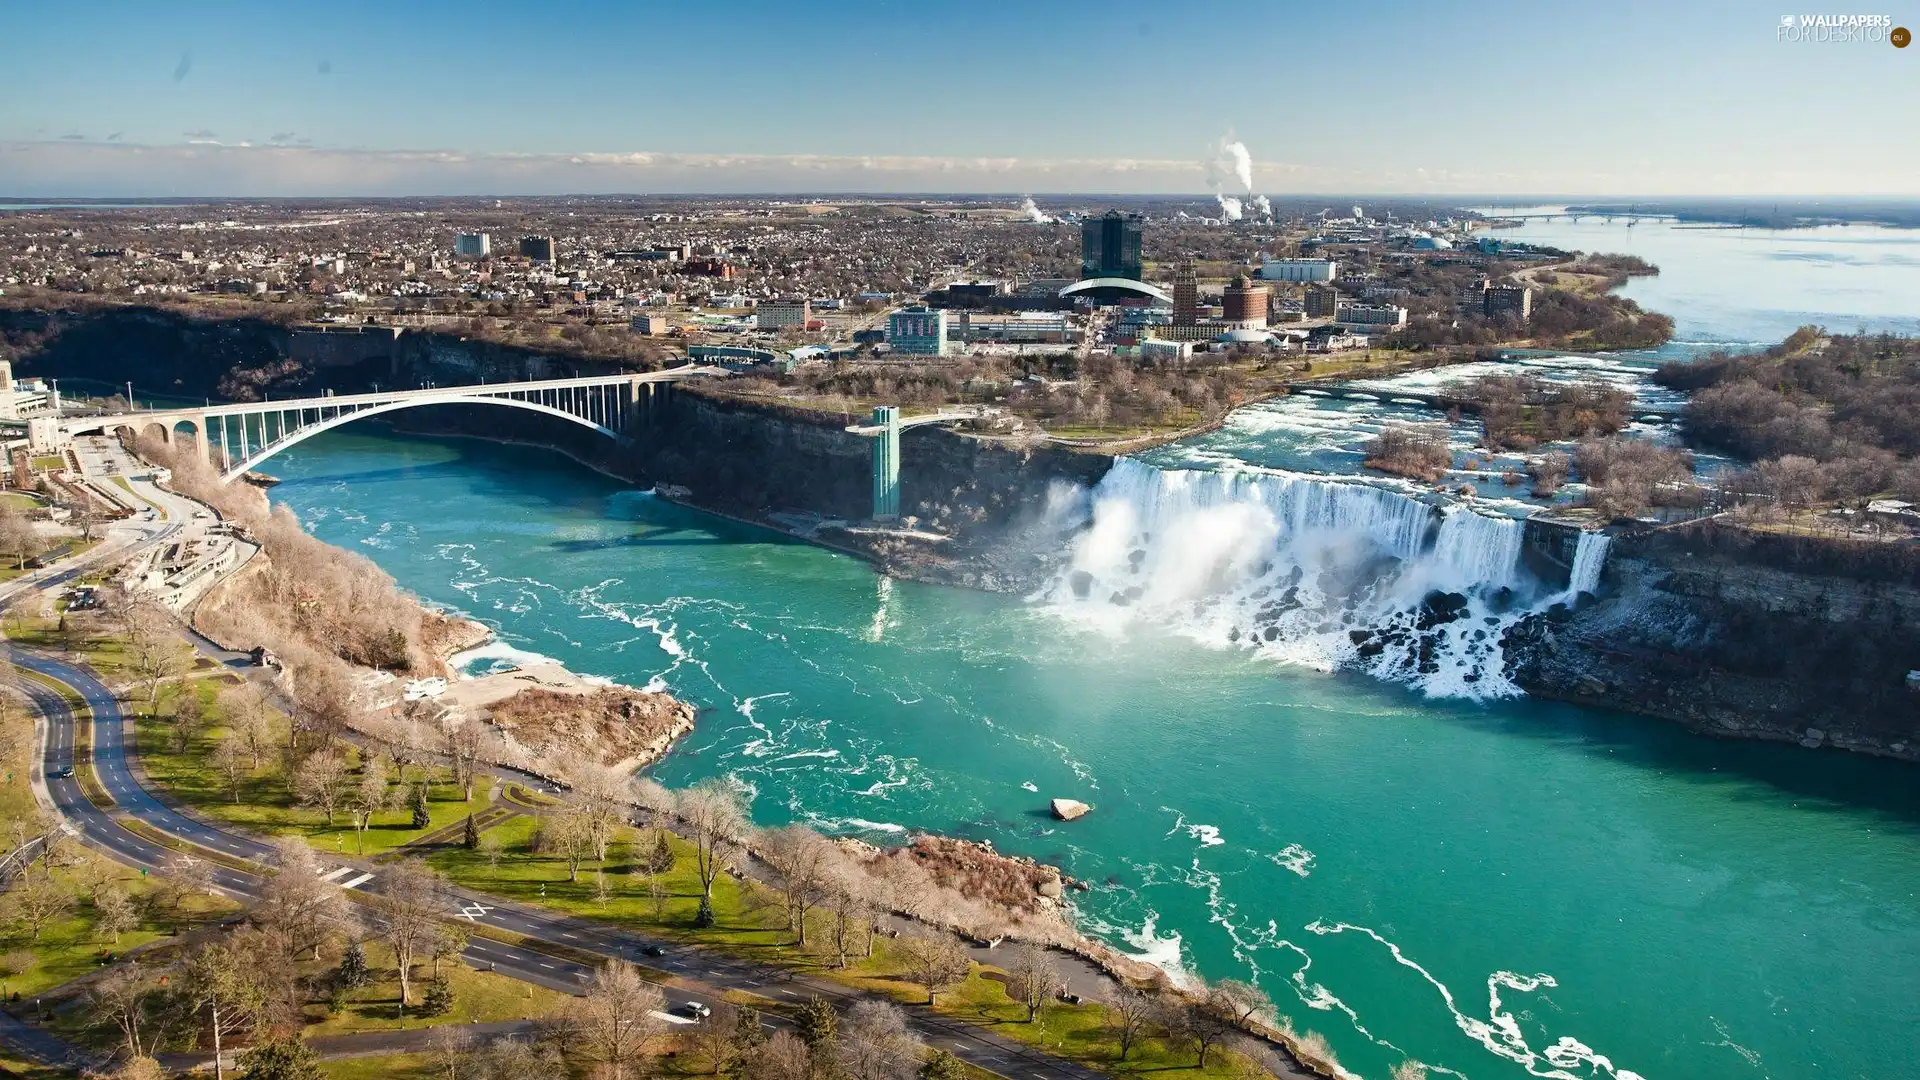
(0, 131, 1912, 198)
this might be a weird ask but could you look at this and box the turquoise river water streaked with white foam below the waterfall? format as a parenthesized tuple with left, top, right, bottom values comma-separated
(259, 212, 1920, 1080)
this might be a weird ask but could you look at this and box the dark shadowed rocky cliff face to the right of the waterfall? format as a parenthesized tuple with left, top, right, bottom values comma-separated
(1507, 522, 1920, 761)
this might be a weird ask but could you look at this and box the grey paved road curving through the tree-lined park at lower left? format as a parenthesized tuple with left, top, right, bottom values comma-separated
(12, 648, 1100, 1080)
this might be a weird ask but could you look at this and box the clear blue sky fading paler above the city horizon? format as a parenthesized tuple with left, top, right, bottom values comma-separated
(0, 0, 1920, 198)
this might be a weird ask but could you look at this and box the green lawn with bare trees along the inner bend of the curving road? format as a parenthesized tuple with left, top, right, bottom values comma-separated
(134, 678, 486, 855)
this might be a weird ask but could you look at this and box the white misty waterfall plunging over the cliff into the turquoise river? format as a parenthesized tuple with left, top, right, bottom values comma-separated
(1044, 457, 1607, 698)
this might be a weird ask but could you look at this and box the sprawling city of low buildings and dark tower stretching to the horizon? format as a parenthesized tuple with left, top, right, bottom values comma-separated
(0, 200, 1532, 374)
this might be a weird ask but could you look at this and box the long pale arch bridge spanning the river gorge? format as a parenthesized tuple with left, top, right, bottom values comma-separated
(58, 367, 722, 480)
